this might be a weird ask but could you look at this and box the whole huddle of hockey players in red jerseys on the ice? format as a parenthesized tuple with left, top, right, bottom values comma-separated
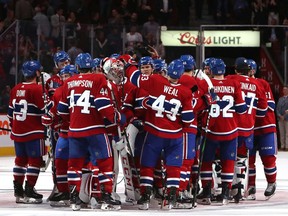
(8, 50, 277, 210)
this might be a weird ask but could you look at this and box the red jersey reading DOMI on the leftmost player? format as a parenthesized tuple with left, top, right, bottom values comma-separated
(7, 82, 45, 142)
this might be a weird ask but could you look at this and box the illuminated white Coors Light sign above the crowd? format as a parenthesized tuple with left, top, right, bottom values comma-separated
(161, 30, 260, 47)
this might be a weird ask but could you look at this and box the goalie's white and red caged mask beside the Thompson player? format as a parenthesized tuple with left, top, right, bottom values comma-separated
(103, 58, 124, 84)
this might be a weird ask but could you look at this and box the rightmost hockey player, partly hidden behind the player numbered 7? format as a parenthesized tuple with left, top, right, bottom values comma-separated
(245, 59, 277, 200)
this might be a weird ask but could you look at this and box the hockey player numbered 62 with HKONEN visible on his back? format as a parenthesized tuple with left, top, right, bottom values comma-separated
(197, 59, 247, 205)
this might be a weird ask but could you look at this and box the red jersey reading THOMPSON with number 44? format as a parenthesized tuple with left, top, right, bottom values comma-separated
(58, 73, 115, 137)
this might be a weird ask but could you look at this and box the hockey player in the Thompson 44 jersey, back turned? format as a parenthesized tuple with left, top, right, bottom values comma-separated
(58, 53, 121, 210)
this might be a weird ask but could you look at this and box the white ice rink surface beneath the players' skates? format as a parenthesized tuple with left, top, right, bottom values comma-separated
(0, 152, 288, 216)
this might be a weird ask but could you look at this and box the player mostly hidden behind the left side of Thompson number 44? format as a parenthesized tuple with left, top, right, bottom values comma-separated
(42, 65, 78, 206)
